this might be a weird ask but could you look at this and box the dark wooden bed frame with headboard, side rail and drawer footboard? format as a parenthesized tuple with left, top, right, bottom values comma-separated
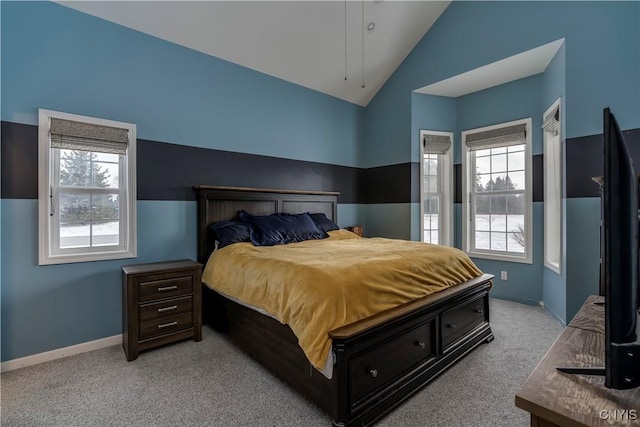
(194, 185, 493, 426)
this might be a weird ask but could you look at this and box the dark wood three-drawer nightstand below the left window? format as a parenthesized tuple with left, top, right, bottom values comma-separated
(122, 260, 202, 361)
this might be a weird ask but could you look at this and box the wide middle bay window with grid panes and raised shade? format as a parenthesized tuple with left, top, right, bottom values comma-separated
(462, 118, 532, 263)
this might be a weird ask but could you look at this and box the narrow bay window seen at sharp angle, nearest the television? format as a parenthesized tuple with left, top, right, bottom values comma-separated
(542, 99, 562, 274)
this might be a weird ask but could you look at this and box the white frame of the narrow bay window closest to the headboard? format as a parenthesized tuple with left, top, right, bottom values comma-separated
(420, 130, 454, 246)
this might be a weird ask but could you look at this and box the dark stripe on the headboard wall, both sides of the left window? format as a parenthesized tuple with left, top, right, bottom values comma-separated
(1, 122, 364, 203)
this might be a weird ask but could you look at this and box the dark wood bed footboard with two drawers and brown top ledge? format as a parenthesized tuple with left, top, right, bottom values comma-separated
(330, 275, 493, 425)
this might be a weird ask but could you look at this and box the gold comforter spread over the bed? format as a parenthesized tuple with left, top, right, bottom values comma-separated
(202, 230, 482, 370)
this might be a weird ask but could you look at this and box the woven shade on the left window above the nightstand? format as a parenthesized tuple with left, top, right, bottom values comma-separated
(49, 117, 129, 154)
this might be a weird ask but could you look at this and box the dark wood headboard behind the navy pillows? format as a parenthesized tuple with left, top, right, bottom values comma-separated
(193, 185, 340, 263)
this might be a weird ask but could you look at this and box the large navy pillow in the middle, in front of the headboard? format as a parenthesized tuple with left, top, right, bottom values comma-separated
(238, 211, 329, 246)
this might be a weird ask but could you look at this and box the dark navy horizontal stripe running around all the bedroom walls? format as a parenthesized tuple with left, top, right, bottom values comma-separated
(5, 121, 616, 204)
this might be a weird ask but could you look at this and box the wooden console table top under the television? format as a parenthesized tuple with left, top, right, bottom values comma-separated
(516, 295, 640, 427)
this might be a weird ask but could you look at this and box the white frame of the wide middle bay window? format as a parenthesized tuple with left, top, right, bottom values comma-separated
(461, 117, 533, 264)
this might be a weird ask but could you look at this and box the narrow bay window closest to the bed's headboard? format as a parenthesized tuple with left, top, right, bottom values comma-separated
(420, 130, 453, 246)
